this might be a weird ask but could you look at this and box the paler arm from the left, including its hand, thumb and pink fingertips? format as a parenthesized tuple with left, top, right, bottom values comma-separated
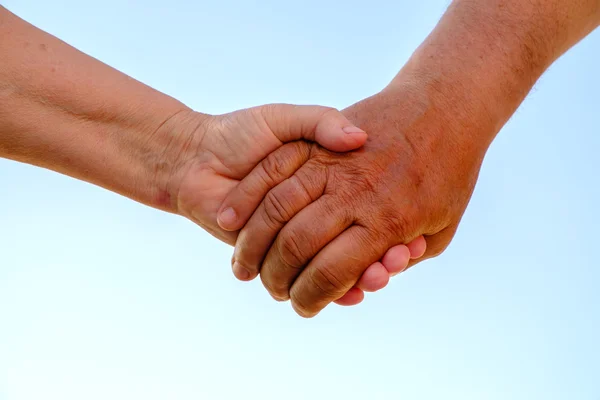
(0, 7, 425, 305)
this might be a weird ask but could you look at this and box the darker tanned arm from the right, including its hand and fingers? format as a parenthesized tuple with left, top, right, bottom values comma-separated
(221, 0, 600, 317)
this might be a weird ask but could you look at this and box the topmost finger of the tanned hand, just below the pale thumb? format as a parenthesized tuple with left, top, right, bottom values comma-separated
(217, 142, 310, 231)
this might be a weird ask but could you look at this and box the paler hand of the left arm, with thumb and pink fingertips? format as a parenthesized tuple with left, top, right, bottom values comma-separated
(158, 104, 424, 305)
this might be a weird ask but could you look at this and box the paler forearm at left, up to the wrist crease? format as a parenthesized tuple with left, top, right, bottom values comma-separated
(0, 7, 192, 208)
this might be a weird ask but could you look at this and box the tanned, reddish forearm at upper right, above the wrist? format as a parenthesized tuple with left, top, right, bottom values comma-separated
(386, 0, 600, 155)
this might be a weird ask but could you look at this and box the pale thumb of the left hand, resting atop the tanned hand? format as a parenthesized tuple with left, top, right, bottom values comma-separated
(257, 104, 367, 152)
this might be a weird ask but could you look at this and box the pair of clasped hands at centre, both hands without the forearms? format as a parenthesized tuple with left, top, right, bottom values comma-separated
(156, 80, 483, 317)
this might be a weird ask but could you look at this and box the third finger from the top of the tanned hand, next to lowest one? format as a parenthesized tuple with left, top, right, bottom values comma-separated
(260, 196, 352, 300)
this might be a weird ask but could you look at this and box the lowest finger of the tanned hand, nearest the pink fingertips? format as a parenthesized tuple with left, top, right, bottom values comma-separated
(290, 225, 389, 318)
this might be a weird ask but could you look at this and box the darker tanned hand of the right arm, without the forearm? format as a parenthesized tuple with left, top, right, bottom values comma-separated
(222, 84, 485, 317)
